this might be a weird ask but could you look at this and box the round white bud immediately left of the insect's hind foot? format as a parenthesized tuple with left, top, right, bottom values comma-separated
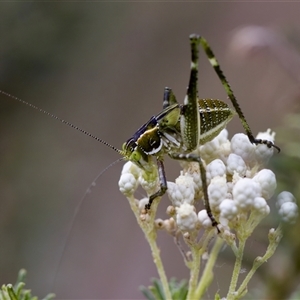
(231, 133, 255, 163)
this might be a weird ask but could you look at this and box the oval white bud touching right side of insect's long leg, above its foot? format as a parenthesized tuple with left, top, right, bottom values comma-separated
(207, 176, 228, 210)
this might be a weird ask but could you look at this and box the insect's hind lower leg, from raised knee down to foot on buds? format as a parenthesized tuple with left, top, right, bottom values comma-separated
(199, 37, 280, 152)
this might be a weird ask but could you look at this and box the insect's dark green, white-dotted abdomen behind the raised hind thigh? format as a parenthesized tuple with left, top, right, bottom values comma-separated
(198, 99, 235, 145)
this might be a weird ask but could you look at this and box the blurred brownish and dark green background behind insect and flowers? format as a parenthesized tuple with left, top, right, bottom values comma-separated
(0, 2, 300, 299)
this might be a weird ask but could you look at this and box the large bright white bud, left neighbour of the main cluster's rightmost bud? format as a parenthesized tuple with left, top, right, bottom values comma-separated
(232, 178, 261, 210)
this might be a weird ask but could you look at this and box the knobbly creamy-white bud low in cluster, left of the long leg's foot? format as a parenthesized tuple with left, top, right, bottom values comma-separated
(176, 203, 198, 231)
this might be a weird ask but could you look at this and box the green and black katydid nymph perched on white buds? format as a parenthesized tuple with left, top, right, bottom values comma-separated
(0, 34, 280, 226)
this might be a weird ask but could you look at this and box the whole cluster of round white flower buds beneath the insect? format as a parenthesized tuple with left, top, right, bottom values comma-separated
(119, 129, 298, 232)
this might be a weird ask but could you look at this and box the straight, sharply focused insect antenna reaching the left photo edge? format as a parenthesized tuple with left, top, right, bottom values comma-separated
(0, 90, 123, 156)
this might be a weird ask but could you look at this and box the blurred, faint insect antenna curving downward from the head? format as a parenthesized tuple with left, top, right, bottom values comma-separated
(50, 157, 126, 291)
